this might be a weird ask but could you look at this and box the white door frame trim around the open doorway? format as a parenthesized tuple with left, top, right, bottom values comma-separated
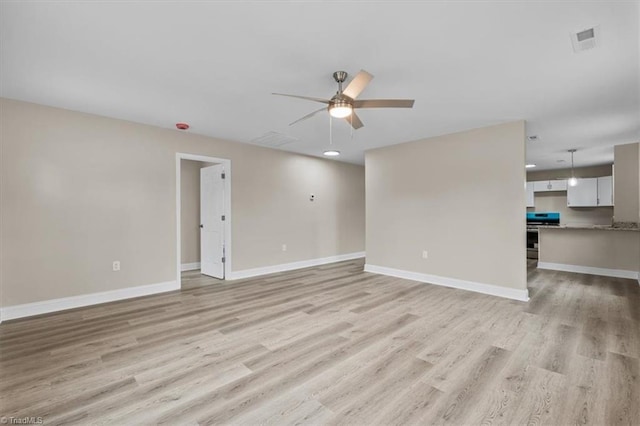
(176, 152, 232, 287)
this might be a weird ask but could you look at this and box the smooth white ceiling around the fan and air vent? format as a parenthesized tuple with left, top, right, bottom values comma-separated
(0, 1, 640, 169)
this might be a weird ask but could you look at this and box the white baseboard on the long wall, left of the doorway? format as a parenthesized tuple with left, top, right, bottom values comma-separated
(0, 281, 180, 320)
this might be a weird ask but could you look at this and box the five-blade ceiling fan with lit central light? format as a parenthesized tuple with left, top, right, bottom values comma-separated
(273, 70, 414, 129)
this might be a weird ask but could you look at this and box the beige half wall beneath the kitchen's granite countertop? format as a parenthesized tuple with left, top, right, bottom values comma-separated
(539, 228, 640, 271)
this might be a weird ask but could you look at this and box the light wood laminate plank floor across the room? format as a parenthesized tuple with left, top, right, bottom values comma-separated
(0, 261, 640, 425)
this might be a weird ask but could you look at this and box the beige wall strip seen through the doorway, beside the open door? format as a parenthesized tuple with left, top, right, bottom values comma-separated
(180, 160, 213, 263)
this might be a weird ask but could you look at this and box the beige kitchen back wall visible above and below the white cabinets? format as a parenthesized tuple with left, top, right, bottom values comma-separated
(527, 164, 613, 225)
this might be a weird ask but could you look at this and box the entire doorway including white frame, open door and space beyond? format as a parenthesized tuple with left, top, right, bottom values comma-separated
(176, 153, 231, 288)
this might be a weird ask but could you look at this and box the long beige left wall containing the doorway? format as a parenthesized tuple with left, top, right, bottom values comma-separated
(0, 99, 365, 306)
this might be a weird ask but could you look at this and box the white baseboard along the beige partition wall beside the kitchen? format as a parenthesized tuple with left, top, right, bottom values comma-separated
(364, 264, 529, 302)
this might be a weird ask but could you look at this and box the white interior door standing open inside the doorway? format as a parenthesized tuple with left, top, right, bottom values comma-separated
(200, 164, 225, 279)
